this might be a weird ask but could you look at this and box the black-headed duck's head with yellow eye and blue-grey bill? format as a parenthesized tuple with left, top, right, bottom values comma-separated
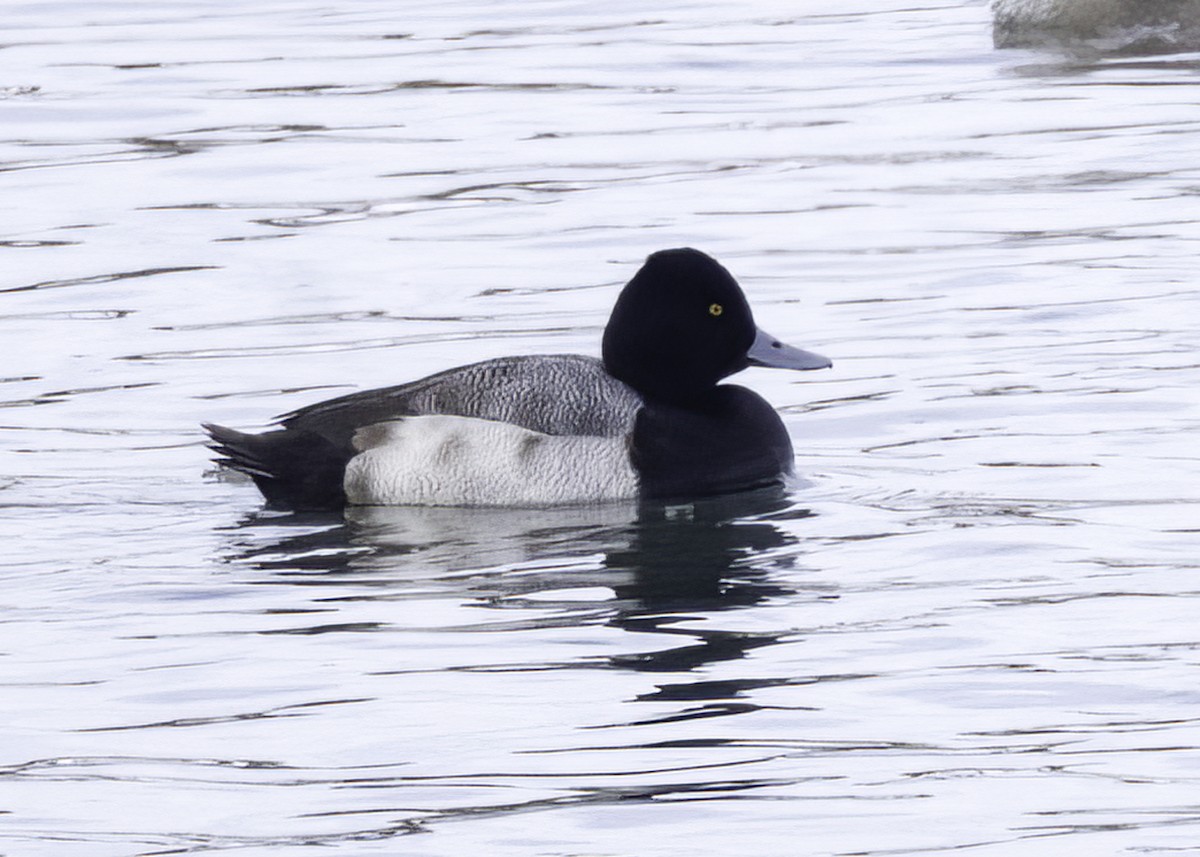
(604, 247, 830, 403)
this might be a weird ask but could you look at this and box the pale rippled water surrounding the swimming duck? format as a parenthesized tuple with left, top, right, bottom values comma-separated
(0, 0, 1200, 857)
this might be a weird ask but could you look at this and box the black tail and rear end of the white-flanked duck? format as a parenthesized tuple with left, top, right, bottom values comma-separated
(204, 422, 354, 511)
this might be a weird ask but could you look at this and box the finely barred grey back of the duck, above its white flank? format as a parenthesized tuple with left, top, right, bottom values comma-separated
(280, 354, 642, 445)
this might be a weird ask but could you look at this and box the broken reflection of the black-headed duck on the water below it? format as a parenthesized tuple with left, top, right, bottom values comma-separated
(220, 487, 810, 686)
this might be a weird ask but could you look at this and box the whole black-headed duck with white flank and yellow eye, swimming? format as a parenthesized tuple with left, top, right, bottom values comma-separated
(203, 247, 833, 511)
